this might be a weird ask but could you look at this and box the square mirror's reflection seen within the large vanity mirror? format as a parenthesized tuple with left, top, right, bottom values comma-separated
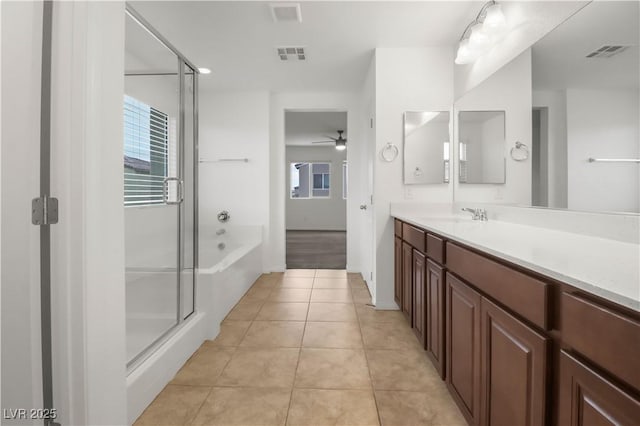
(458, 111, 506, 183)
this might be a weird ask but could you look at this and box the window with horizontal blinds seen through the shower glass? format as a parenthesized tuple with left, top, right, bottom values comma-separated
(124, 95, 169, 206)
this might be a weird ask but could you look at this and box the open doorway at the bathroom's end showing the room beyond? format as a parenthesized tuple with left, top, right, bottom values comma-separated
(285, 110, 348, 269)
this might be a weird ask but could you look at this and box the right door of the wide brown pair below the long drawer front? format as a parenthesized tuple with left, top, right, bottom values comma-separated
(480, 298, 549, 426)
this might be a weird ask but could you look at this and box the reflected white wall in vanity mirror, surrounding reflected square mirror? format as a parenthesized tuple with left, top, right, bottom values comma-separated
(453, 49, 532, 205)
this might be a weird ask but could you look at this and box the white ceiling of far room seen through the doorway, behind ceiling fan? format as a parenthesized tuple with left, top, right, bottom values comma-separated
(284, 111, 349, 147)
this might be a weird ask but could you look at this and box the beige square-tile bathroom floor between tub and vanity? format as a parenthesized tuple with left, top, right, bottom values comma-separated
(135, 269, 466, 426)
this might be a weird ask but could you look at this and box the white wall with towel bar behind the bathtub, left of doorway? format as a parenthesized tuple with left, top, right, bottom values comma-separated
(199, 90, 271, 262)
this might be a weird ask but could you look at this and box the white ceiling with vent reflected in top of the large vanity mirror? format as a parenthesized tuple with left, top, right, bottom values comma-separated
(532, 1, 640, 90)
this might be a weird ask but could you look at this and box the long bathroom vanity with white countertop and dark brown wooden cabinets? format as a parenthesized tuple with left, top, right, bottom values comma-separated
(392, 211, 640, 426)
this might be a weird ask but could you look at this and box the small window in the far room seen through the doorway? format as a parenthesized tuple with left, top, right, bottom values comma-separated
(289, 162, 331, 198)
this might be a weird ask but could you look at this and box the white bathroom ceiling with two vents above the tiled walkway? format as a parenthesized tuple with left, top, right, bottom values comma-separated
(132, 1, 482, 91)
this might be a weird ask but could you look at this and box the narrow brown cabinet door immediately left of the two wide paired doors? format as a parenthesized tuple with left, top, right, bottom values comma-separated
(425, 259, 445, 379)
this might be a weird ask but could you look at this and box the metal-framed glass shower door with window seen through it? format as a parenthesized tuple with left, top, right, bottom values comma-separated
(124, 15, 184, 366)
